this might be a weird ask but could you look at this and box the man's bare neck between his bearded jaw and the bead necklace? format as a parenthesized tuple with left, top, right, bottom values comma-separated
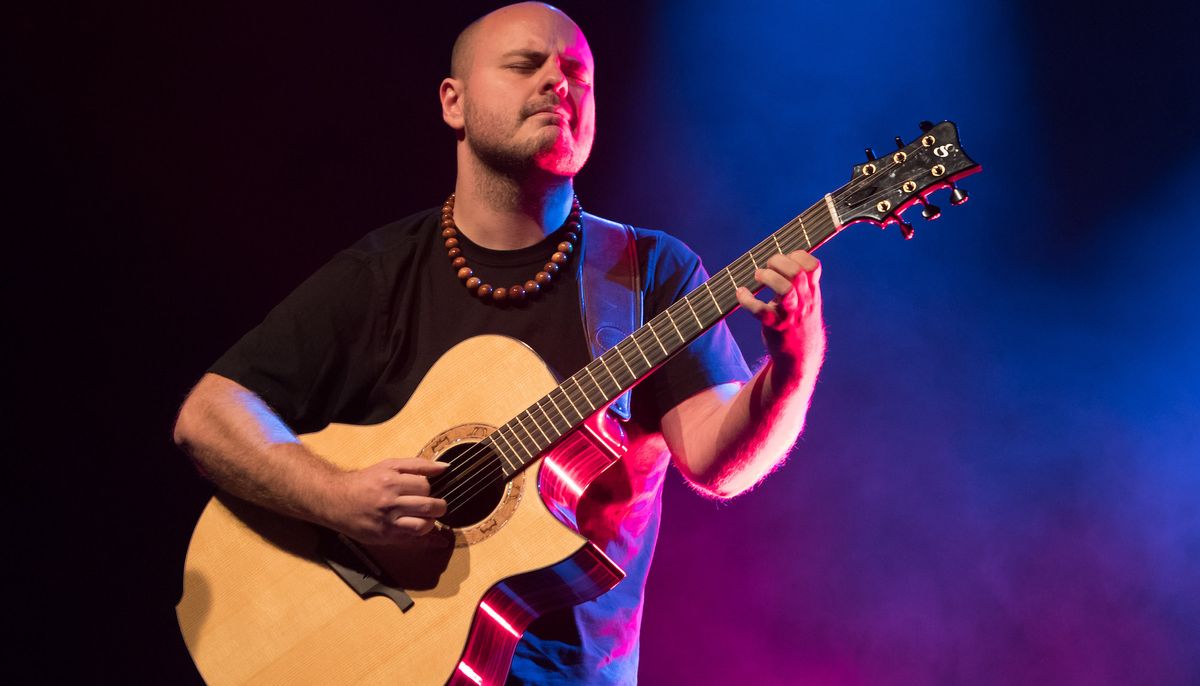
(454, 150, 575, 251)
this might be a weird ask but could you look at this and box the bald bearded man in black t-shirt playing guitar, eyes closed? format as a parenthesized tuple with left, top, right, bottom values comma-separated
(175, 2, 824, 684)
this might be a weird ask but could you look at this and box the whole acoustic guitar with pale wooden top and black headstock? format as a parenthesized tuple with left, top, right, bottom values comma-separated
(176, 121, 980, 686)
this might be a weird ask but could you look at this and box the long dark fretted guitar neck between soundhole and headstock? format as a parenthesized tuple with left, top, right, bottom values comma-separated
(487, 190, 845, 477)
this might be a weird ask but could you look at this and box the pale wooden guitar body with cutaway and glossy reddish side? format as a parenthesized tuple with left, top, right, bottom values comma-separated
(176, 336, 624, 685)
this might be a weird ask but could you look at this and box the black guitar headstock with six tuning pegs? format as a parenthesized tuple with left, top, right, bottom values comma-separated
(830, 121, 982, 239)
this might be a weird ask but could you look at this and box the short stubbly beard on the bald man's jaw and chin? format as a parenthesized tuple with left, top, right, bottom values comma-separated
(463, 96, 592, 179)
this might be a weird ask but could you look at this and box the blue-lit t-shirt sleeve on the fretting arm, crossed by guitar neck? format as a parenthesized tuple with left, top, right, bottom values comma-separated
(634, 231, 750, 426)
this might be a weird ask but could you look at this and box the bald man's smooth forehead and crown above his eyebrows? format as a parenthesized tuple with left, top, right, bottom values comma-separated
(475, 7, 593, 68)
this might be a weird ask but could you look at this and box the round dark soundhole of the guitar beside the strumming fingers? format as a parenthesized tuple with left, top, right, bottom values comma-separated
(430, 443, 506, 529)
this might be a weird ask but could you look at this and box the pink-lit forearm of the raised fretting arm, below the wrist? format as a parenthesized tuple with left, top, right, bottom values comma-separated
(676, 348, 823, 498)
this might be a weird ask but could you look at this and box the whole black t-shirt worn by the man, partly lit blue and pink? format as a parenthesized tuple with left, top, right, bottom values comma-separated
(210, 209, 750, 684)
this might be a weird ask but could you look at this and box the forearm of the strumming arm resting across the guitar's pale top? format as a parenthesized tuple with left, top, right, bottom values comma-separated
(175, 374, 340, 524)
